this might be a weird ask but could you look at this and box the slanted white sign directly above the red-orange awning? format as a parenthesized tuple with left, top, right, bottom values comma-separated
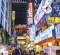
(36, 25, 54, 41)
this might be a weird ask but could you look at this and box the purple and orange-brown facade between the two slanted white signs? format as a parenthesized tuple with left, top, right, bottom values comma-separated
(36, 16, 48, 35)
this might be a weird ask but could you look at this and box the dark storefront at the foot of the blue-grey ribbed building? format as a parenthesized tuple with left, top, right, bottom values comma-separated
(0, 28, 12, 45)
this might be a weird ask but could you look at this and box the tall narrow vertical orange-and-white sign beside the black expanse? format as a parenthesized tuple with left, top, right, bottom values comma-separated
(27, 3, 33, 24)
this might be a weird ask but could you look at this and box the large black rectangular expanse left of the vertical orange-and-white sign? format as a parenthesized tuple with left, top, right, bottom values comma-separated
(12, 3, 27, 25)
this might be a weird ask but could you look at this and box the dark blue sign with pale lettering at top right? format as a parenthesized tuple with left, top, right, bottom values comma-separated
(52, 3, 60, 16)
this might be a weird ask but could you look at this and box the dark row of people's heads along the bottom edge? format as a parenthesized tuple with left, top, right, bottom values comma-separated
(12, 48, 48, 55)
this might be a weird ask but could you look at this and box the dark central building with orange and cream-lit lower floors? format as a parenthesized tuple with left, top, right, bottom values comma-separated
(12, 0, 27, 47)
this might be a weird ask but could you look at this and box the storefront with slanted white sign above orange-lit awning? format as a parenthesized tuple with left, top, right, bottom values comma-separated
(35, 25, 55, 46)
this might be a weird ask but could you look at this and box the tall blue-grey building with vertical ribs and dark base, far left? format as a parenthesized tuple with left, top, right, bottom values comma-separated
(0, 0, 11, 44)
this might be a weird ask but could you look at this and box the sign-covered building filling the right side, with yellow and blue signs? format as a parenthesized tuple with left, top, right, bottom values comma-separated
(34, 0, 60, 46)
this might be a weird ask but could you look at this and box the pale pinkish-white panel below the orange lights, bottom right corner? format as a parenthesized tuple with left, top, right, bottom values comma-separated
(43, 46, 60, 55)
